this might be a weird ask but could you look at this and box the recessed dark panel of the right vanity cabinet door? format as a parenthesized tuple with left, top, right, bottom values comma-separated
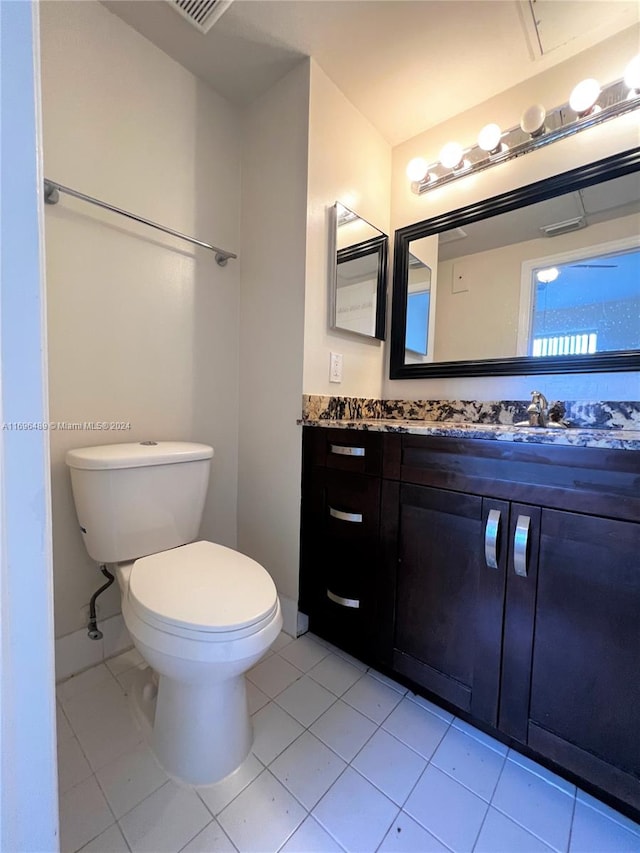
(505, 509, 640, 809)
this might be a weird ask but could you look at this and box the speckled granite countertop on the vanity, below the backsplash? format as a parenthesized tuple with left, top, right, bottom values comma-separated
(298, 418, 640, 450)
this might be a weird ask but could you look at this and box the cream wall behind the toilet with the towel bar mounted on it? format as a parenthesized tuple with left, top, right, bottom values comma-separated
(41, 2, 240, 636)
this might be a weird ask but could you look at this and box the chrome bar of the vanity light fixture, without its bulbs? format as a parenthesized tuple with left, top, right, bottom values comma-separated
(411, 80, 640, 195)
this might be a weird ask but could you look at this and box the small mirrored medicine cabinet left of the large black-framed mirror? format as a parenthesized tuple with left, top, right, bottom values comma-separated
(329, 202, 389, 340)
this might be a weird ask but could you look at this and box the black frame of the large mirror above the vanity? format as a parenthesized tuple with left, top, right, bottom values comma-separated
(389, 147, 640, 379)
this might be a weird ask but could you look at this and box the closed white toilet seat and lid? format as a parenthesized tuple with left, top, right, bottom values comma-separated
(127, 541, 278, 642)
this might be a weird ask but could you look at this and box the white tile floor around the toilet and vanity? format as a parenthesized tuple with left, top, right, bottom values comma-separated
(58, 634, 640, 853)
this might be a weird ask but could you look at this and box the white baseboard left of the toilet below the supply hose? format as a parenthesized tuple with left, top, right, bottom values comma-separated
(56, 613, 133, 681)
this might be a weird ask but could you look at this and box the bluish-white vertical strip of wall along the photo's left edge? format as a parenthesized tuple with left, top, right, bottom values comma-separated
(0, 3, 58, 853)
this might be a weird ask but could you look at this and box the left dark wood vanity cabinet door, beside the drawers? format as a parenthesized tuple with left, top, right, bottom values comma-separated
(392, 484, 508, 724)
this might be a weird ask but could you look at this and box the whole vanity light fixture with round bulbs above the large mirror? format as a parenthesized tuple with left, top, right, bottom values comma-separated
(407, 54, 640, 195)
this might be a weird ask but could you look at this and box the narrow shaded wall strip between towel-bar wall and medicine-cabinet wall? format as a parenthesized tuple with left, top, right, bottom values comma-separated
(238, 61, 309, 608)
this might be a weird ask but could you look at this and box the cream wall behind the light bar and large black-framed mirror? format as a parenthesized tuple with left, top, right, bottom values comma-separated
(384, 27, 640, 400)
